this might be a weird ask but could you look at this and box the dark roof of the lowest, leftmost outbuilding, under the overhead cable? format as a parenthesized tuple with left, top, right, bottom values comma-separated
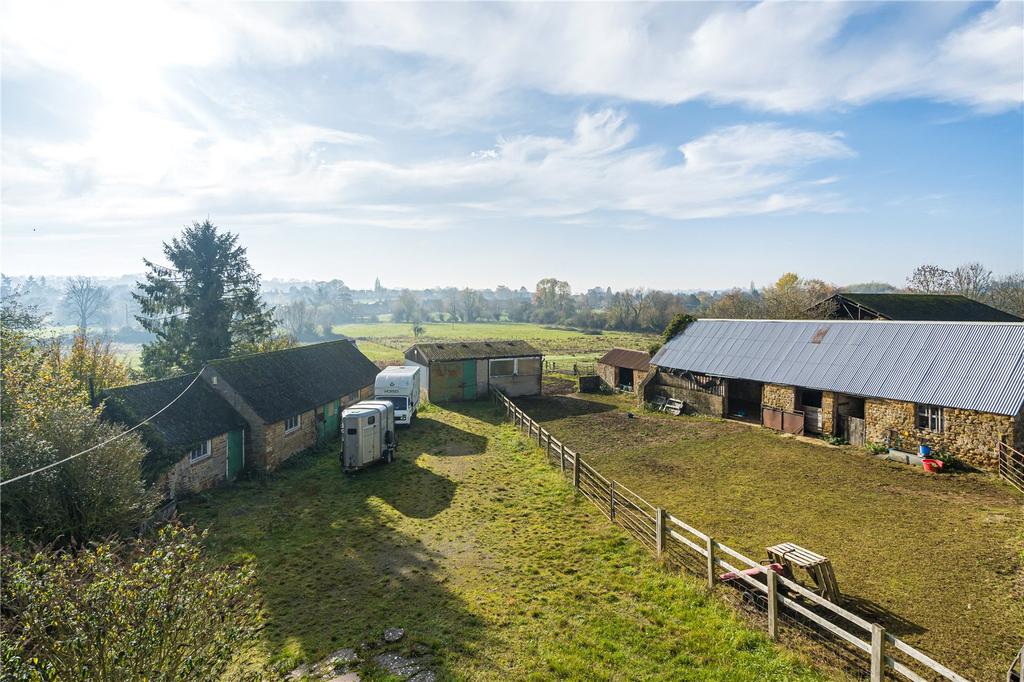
(100, 373, 246, 451)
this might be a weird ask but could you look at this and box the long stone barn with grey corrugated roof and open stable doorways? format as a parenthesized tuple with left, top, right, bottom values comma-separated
(640, 319, 1024, 469)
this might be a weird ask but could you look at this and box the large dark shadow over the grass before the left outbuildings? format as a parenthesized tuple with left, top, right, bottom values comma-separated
(185, 420, 486, 679)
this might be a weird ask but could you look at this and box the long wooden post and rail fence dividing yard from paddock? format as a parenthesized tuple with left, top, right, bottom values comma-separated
(494, 390, 968, 682)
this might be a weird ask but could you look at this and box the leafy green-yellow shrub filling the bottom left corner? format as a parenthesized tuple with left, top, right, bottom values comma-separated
(0, 525, 261, 680)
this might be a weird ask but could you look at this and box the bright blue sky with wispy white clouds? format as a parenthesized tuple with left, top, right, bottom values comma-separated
(0, 2, 1024, 291)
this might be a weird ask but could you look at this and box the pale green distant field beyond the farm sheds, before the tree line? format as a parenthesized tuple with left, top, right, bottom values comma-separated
(333, 323, 657, 361)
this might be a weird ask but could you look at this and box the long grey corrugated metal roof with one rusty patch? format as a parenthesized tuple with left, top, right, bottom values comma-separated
(651, 319, 1024, 415)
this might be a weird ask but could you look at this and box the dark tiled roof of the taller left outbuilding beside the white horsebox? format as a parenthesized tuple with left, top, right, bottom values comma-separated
(209, 339, 380, 423)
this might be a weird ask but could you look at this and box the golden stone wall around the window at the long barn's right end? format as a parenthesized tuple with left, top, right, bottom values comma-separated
(864, 398, 1020, 469)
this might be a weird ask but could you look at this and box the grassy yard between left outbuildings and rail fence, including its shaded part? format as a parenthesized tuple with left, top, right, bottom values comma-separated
(183, 402, 824, 682)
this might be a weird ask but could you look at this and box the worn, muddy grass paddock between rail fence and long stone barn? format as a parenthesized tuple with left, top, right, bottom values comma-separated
(519, 395, 1024, 680)
